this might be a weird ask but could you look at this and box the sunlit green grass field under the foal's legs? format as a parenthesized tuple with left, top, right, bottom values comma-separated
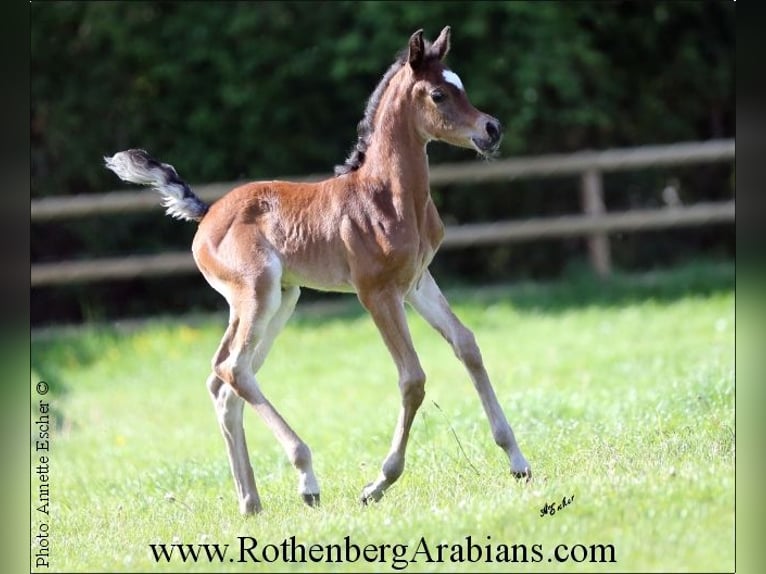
(31, 264, 735, 572)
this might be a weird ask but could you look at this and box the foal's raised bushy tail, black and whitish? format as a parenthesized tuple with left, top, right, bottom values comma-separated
(104, 149, 209, 221)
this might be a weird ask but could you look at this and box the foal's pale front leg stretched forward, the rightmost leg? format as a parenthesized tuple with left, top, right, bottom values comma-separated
(407, 271, 532, 478)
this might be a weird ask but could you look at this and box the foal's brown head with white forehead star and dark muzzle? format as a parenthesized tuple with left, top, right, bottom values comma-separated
(402, 26, 502, 156)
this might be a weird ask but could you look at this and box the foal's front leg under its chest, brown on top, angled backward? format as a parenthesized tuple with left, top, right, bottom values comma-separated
(359, 292, 426, 504)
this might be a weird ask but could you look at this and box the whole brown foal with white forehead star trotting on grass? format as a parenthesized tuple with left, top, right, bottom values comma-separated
(105, 27, 530, 513)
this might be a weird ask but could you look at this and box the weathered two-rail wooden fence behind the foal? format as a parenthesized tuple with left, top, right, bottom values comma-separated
(31, 140, 735, 287)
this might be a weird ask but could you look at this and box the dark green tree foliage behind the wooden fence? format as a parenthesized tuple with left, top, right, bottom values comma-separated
(31, 1, 734, 322)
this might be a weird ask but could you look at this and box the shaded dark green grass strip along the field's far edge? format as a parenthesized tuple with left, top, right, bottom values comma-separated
(31, 262, 735, 388)
